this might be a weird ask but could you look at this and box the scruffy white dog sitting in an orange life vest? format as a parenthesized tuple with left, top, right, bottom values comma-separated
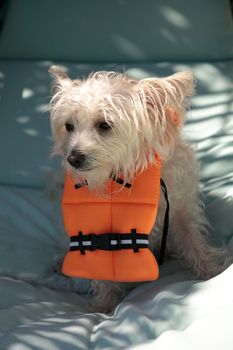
(50, 66, 228, 312)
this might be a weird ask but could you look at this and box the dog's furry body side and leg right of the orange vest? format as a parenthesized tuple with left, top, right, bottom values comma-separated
(156, 140, 231, 279)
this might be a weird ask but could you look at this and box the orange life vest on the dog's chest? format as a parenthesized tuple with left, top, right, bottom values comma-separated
(62, 159, 162, 282)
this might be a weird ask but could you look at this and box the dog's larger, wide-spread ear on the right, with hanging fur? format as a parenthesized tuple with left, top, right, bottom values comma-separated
(135, 71, 195, 159)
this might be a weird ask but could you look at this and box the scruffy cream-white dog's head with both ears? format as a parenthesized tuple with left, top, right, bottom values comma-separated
(50, 66, 194, 189)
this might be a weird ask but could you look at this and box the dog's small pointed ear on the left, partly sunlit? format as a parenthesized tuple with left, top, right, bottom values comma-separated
(49, 66, 72, 94)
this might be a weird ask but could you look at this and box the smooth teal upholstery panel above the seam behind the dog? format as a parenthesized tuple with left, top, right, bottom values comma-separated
(0, 0, 233, 63)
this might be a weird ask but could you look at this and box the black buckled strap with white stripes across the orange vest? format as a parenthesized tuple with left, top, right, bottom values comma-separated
(70, 229, 149, 254)
